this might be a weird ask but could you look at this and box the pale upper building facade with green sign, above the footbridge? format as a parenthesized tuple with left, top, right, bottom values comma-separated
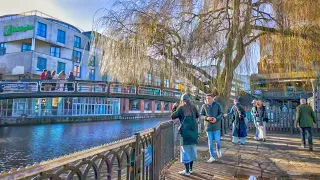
(0, 11, 102, 80)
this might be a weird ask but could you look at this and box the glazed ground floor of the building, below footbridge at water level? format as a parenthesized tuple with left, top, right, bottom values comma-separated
(0, 97, 175, 117)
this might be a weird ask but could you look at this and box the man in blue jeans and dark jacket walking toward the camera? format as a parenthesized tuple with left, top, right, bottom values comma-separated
(200, 94, 222, 163)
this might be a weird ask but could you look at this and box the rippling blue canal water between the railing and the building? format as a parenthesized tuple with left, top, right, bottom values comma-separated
(0, 119, 167, 172)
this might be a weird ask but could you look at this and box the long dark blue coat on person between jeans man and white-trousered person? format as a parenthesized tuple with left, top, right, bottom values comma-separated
(232, 107, 247, 137)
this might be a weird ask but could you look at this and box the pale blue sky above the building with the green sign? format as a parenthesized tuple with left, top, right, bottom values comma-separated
(0, 0, 114, 31)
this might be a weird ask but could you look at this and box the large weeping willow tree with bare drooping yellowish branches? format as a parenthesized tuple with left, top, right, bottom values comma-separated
(93, 0, 320, 108)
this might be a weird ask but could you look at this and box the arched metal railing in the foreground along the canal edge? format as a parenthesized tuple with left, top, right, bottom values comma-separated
(0, 121, 180, 180)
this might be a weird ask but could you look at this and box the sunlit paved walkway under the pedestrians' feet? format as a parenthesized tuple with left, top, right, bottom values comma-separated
(165, 134, 320, 180)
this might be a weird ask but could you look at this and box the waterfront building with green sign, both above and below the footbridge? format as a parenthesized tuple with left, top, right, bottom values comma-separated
(0, 11, 178, 117)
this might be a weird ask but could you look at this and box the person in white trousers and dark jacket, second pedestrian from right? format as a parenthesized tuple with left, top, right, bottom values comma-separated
(251, 100, 268, 142)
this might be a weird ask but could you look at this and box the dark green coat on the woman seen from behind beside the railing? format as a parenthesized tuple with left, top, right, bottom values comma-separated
(171, 106, 199, 145)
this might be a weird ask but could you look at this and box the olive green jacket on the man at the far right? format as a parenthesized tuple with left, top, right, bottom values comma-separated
(295, 104, 316, 127)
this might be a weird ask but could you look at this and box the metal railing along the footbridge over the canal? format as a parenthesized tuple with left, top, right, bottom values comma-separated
(0, 80, 203, 100)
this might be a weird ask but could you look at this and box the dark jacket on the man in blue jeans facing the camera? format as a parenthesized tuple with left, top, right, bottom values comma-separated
(201, 101, 222, 131)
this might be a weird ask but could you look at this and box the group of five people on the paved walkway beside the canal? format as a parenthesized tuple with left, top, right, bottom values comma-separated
(171, 94, 316, 176)
